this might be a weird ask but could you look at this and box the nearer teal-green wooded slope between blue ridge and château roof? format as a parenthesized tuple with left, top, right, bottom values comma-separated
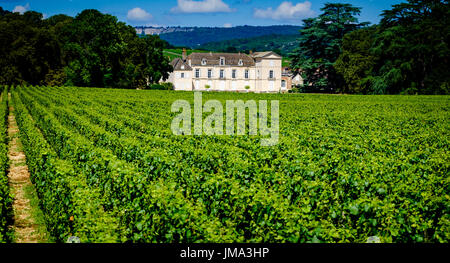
(199, 34, 299, 57)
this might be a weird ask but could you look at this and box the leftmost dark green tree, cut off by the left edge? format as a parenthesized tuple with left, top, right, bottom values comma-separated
(0, 11, 61, 85)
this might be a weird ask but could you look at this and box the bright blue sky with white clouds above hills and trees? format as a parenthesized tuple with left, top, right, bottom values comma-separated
(0, 0, 406, 27)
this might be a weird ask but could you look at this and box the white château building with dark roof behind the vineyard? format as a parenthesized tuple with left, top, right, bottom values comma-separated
(167, 50, 291, 93)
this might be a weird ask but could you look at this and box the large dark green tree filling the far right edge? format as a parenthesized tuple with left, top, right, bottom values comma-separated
(370, 0, 450, 94)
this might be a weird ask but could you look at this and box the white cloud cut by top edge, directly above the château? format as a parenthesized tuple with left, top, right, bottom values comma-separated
(170, 0, 234, 13)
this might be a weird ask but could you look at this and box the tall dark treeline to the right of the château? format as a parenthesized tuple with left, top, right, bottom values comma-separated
(291, 0, 450, 94)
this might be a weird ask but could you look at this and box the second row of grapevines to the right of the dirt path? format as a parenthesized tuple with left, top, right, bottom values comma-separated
(16, 87, 232, 242)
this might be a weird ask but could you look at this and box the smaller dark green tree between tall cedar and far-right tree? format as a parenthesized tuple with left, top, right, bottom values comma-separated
(334, 26, 378, 94)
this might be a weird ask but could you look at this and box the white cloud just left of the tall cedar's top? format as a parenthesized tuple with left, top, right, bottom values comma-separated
(253, 1, 314, 20)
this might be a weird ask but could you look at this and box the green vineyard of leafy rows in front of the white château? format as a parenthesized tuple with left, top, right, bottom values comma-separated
(0, 87, 450, 243)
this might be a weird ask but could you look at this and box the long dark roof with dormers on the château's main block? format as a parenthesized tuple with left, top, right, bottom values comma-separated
(187, 53, 255, 67)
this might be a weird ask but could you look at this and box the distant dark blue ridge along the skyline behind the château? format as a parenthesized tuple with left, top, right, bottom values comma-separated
(153, 25, 301, 48)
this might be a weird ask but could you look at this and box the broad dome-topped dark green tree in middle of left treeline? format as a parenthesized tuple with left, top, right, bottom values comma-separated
(61, 10, 129, 87)
